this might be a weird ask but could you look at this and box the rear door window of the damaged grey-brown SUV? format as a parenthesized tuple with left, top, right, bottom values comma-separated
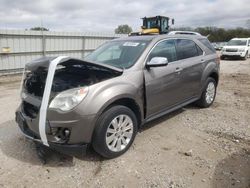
(176, 39, 203, 60)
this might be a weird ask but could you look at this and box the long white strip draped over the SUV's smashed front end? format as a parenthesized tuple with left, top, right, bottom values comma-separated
(39, 56, 68, 146)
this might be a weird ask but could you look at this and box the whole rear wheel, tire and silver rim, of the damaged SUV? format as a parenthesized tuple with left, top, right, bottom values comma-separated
(196, 77, 217, 108)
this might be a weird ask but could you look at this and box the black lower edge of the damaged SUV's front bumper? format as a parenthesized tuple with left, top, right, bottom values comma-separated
(16, 112, 89, 157)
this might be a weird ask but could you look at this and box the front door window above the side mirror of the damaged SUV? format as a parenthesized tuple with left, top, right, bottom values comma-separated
(149, 39, 177, 62)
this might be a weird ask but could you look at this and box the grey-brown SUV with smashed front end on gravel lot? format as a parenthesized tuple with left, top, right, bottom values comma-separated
(16, 35, 219, 158)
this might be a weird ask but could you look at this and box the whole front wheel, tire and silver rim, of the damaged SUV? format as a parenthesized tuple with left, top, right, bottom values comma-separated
(92, 105, 137, 159)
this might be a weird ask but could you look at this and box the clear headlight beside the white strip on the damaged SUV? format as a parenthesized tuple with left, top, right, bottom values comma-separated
(49, 87, 89, 111)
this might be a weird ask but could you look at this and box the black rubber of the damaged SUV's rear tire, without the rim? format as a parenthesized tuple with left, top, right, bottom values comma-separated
(196, 77, 217, 108)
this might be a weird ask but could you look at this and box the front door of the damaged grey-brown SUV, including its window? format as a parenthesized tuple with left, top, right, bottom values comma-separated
(144, 39, 181, 117)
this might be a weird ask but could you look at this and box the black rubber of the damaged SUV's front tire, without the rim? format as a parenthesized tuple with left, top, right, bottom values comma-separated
(92, 105, 138, 159)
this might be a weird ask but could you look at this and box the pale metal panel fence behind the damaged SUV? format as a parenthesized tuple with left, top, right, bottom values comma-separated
(0, 30, 124, 75)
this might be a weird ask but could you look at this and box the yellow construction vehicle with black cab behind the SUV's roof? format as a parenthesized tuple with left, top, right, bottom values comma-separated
(130, 16, 174, 35)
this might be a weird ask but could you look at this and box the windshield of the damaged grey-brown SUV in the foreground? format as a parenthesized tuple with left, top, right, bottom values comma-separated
(84, 41, 148, 69)
